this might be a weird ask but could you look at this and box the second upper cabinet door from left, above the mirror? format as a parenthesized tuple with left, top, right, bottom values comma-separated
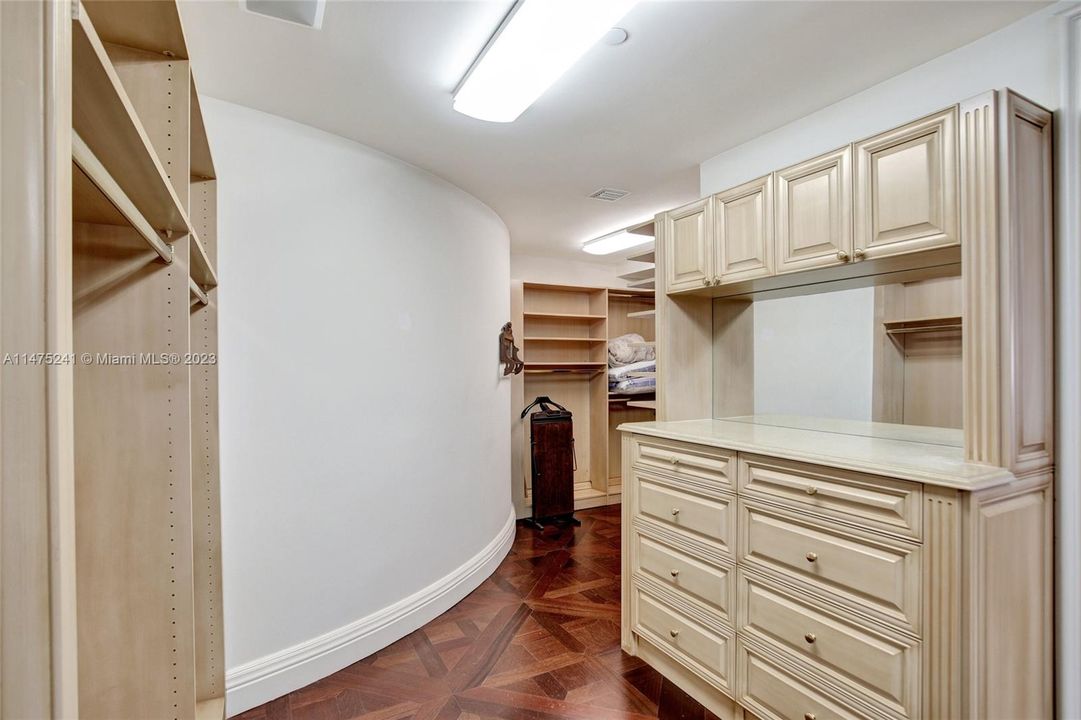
(713, 175, 773, 284)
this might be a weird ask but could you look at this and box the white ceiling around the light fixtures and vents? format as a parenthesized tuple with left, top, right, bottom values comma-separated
(182, 0, 1044, 259)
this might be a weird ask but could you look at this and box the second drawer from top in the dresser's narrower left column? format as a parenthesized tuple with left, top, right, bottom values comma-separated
(635, 472, 735, 554)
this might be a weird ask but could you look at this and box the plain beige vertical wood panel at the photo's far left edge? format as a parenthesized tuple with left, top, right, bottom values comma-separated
(0, 1, 77, 718)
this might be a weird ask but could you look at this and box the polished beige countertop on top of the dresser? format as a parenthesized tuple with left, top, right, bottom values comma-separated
(619, 415, 1014, 491)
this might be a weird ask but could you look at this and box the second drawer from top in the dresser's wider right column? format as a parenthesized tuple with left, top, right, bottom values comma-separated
(739, 498, 920, 635)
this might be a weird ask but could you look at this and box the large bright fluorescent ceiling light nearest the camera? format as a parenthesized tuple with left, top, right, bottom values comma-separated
(454, 0, 637, 122)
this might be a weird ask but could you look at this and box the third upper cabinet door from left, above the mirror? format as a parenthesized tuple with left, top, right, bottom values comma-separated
(774, 145, 852, 275)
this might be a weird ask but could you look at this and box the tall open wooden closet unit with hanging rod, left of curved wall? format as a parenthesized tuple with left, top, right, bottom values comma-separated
(71, 0, 225, 720)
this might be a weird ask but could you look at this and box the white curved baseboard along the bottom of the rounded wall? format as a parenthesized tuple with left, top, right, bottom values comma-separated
(225, 508, 515, 716)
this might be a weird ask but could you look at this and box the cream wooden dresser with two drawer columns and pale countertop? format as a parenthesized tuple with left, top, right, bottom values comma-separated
(620, 415, 1053, 720)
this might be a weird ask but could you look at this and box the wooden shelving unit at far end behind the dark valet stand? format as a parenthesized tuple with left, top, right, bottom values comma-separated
(511, 282, 655, 514)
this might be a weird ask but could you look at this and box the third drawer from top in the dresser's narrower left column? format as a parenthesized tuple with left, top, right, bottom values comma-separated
(631, 532, 735, 622)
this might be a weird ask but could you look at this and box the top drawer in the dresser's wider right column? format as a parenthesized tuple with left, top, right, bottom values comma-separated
(739, 455, 922, 539)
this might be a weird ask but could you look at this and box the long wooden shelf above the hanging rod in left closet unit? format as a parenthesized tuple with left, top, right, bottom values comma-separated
(71, 3, 190, 235)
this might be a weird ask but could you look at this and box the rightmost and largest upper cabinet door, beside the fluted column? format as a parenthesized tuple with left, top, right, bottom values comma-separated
(853, 107, 961, 259)
